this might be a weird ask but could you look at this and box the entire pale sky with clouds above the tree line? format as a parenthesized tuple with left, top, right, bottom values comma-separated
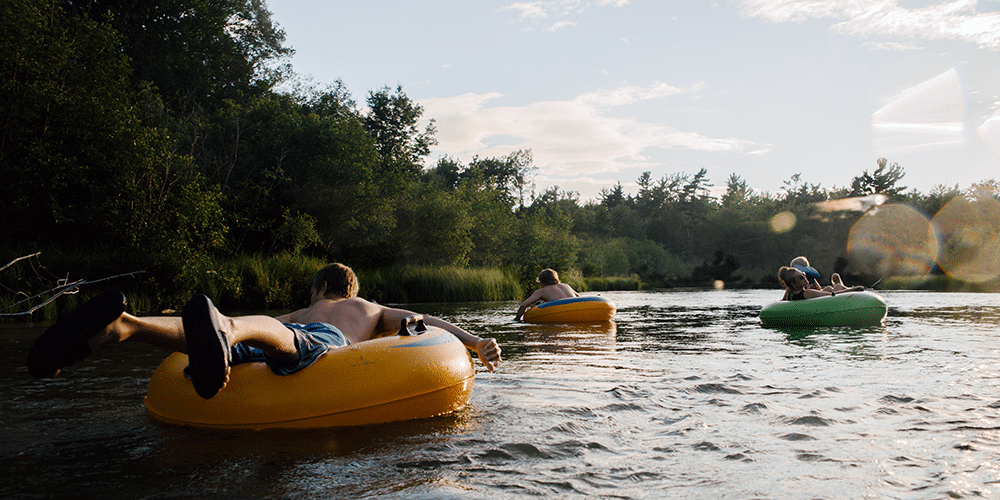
(266, 0, 1000, 201)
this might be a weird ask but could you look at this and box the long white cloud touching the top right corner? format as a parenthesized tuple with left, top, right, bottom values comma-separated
(735, 0, 1000, 50)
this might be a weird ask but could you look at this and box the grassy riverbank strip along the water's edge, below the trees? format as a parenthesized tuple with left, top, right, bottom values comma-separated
(0, 254, 643, 321)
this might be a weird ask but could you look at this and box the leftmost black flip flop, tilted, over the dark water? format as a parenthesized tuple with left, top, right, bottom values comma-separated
(28, 290, 127, 378)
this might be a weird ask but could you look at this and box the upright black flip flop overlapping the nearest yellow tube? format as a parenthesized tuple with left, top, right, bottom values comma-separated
(181, 295, 230, 399)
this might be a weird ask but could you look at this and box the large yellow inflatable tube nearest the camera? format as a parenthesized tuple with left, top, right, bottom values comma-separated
(145, 317, 475, 430)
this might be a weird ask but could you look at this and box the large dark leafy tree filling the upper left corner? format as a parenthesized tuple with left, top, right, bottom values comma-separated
(0, 0, 219, 251)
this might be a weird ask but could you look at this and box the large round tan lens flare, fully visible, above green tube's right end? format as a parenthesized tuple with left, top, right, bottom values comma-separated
(847, 205, 938, 279)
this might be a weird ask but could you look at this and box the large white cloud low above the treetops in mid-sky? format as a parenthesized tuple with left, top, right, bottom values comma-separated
(420, 82, 759, 178)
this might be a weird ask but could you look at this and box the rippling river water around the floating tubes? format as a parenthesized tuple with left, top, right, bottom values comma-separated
(0, 290, 1000, 499)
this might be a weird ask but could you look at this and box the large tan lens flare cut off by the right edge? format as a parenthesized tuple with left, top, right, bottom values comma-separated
(933, 196, 1000, 283)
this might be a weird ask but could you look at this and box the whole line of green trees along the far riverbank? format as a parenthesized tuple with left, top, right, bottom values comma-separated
(0, 0, 996, 308)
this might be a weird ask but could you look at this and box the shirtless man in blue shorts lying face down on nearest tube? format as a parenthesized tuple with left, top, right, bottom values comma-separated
(28, 264, 501, 399)
